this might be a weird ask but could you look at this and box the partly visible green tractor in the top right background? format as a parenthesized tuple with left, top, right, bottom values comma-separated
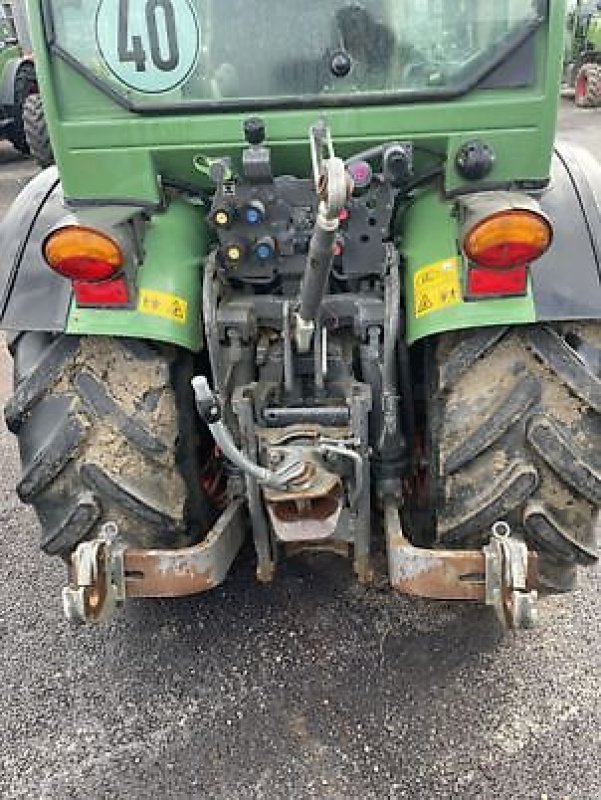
(563, 0, 601, 108)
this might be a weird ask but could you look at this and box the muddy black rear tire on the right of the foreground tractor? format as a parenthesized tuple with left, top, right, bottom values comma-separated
(418, 322, 601, 591)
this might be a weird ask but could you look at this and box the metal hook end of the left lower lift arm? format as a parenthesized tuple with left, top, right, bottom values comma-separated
(63, 522, 126, 623)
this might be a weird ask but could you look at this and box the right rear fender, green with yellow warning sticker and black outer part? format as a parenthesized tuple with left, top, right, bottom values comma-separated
(399, 144, 601, 344)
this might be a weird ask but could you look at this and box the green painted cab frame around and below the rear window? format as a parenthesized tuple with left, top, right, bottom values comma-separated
(29, 0, 565, 201)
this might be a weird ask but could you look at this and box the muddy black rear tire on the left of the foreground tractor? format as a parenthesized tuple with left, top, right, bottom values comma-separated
(5, 333, 211, 558)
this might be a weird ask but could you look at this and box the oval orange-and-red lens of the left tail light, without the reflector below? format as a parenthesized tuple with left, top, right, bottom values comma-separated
(43, 225, 123, 281)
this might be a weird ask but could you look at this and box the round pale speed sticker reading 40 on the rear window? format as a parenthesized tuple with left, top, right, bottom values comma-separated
(96, 0, 201, 94)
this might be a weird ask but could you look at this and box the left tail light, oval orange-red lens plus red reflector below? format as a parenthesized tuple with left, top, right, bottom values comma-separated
(42, 225, 129, 306)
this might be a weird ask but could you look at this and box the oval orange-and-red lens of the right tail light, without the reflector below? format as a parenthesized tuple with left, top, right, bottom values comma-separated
(463, 209, 553, 269)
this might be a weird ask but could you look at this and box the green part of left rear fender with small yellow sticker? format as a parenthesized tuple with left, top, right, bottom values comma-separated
(66, 200, 208, 351)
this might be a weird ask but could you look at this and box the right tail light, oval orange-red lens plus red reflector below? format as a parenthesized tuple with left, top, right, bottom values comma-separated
(463, 198, 553, 299)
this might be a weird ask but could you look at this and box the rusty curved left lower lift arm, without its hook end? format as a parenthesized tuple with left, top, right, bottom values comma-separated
(123, 498, 246, 597)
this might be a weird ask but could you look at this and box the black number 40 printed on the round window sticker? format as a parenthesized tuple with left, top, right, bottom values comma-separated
(117, 0, 179, 72)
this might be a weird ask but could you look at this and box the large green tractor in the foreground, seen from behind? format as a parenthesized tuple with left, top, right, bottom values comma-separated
(1, 0, 601, 627)
